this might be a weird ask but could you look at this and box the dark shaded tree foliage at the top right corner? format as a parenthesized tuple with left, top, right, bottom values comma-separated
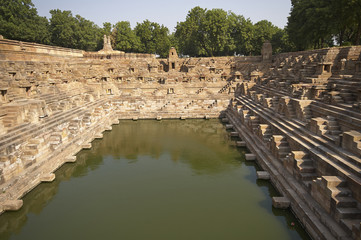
(287, 0, 361, 50)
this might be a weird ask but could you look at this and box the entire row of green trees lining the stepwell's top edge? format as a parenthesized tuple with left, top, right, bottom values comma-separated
(0, 0, 361, 57)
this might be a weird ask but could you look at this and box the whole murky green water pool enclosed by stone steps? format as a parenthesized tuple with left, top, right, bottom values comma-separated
(0, 120, 308, 240)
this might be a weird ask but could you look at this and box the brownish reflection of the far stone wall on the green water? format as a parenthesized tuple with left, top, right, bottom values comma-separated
(91, 120, 244, 174)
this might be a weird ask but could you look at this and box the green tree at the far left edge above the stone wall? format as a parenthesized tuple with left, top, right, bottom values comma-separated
(0, 0, 50, 44)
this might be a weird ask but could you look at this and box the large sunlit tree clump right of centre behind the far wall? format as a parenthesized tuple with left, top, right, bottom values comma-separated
(175, 7, 288, 56)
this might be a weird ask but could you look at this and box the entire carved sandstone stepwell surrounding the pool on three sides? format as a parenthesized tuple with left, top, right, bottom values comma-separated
(0, 37, 361, 240)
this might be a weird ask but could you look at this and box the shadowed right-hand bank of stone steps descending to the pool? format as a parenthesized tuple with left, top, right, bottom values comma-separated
(226, 47, 361, 239)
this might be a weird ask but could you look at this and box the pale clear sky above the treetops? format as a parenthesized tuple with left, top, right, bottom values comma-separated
(32, 0, 291, 32)
